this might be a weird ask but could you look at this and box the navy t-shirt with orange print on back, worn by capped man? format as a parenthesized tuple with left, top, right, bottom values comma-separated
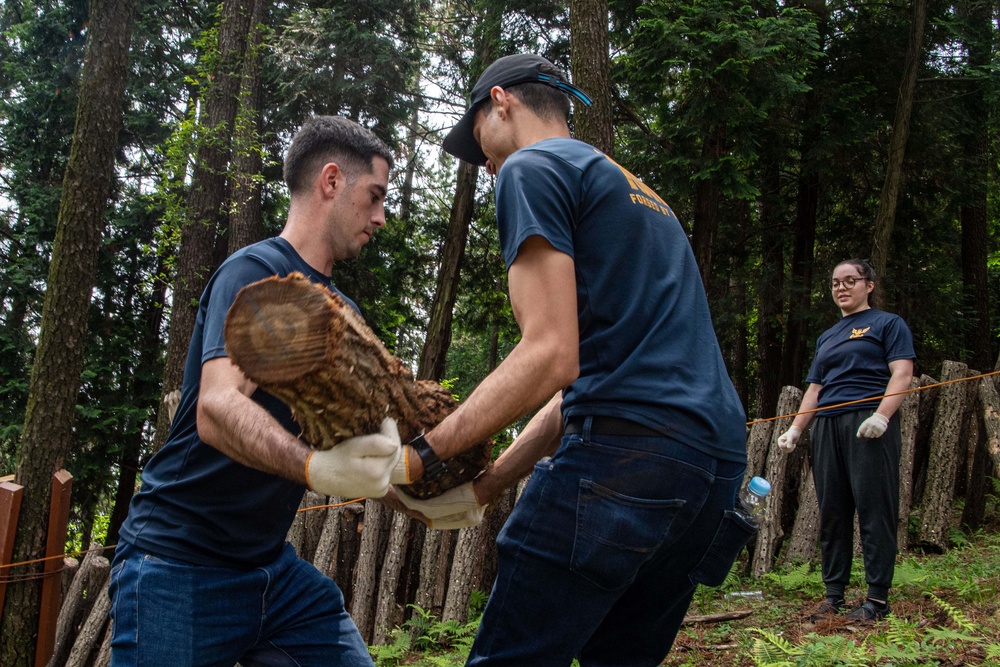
(496, 138, 746, 461)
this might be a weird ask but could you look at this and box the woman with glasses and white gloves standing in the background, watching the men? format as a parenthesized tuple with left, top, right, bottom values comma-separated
(778, 259, 916, 622)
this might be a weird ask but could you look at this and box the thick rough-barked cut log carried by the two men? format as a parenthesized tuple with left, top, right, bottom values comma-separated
(225, 273, 491, 498)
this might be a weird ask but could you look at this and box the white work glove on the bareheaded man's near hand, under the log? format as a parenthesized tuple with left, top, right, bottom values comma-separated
(306, 417, 403, 498)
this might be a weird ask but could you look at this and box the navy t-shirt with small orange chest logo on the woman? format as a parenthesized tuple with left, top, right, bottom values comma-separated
(806, 308, 917, 417)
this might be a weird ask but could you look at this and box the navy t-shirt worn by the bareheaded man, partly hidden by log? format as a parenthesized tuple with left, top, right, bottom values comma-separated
(121, 238, 357, 567)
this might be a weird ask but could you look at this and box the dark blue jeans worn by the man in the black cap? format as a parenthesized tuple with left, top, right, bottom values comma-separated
(466, 419, 754, 667)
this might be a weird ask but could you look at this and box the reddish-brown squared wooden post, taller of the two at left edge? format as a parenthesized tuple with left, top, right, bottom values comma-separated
(35, 468, 73, 667)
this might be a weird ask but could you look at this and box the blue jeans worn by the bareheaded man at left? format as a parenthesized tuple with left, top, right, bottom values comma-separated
(108, 542, 373, 667)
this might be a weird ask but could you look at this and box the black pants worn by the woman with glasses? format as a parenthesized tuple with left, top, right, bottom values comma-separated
(811, 410, 902, 600)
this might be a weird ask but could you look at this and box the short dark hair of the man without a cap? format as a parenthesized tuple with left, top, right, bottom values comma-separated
(284, 116, 393, 195)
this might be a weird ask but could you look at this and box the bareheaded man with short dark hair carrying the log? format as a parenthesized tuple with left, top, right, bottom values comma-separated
(109, 116, 406, 667)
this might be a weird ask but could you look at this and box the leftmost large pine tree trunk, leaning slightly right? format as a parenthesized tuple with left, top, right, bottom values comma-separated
(0, 0, 136, 667)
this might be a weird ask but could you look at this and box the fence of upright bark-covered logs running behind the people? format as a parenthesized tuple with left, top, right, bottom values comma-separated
(0, 362, 1000, 667)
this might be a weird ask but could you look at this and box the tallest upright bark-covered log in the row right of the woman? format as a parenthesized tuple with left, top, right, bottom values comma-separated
(916, 361, 968, 552)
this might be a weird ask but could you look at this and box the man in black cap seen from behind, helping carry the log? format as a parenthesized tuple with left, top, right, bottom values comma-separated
(390, 55, 753, 667)
